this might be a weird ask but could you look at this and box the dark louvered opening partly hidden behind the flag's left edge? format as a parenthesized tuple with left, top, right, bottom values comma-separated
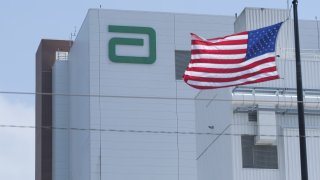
(175, 51, 191, 80)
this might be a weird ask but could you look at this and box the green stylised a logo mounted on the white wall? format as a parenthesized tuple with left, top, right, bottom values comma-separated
(108, 25, 156, 64)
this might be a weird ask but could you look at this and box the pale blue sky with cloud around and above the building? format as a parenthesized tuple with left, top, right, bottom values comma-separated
(0, 0, 320, 180)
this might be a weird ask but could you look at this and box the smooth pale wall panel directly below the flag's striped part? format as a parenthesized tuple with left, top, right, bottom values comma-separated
(196, 89, 233, 180)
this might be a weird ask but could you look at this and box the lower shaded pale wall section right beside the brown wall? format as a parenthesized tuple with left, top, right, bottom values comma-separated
(52, 61, 69, 180)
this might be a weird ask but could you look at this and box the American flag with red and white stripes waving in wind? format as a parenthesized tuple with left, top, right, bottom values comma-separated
(183, 22, 282, 89)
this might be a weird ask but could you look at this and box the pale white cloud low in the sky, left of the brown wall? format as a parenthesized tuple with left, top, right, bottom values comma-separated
(0, 96, 35, 180)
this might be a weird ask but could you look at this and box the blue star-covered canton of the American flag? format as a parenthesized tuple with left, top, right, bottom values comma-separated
(246, 22, 282, 60)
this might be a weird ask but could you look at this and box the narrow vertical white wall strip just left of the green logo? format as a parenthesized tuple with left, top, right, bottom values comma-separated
(87, 9, 102, 179)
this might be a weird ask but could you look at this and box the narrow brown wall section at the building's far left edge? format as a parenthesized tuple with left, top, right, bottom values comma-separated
(35, 39, 72, 180)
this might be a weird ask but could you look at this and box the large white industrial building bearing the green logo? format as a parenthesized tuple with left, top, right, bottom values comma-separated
(36, 8, 320, 180)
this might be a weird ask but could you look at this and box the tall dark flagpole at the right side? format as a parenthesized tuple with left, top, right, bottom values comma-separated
(292, 0, 308, 180)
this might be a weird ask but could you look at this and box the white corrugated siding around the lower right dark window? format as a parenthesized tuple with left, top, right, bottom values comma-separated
(232, 113, 320, 180)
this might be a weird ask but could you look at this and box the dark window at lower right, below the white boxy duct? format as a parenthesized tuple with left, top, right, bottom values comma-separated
(241, 135, 278, 169)
